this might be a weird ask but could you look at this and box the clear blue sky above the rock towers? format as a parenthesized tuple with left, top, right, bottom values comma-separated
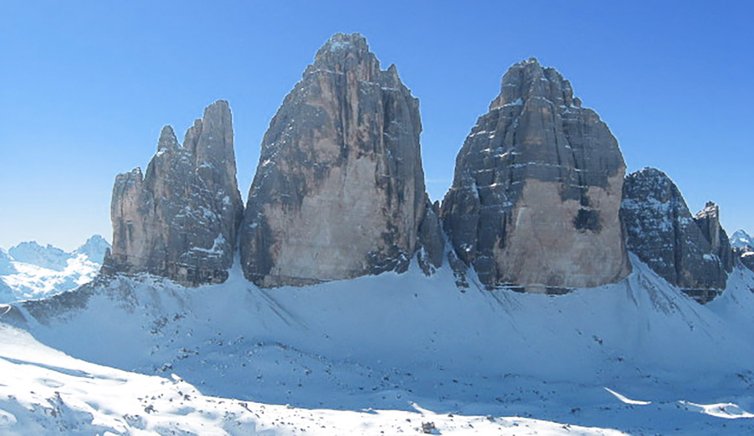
(0, 0, 754, 249)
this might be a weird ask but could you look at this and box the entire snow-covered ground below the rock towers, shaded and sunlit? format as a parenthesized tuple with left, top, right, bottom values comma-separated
(0, 257, 754, 434)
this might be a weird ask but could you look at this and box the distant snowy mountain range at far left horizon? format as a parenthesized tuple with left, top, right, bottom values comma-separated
(0, 235, 110, 303)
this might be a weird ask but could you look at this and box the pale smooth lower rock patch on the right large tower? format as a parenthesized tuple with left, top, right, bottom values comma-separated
(493, 175, 628, 292)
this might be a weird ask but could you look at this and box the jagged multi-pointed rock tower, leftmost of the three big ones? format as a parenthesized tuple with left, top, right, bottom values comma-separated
(103, 101, 243, 285)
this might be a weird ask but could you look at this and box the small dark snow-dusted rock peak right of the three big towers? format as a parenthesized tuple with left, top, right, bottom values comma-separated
(621, 168, 733, 300)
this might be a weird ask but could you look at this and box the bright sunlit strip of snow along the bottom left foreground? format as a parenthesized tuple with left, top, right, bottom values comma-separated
(0, 324, 618, 435)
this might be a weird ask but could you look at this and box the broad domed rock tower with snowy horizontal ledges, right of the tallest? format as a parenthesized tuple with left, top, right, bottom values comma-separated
(442, 59, 630, 291)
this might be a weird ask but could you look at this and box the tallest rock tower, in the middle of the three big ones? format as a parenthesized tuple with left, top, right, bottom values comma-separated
(240, 34, 442, 287)
